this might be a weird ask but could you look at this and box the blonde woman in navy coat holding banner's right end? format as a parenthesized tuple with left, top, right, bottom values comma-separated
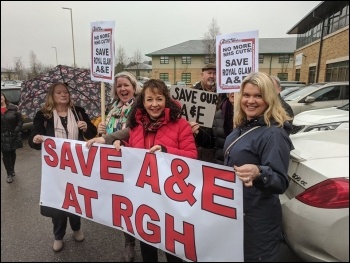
(224, 72, 293, 262)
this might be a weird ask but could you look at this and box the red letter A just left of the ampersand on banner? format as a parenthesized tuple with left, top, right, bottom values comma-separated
(136, 153, 160, 194)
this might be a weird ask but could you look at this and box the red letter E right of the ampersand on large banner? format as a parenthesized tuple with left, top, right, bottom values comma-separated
(202, 165, 237, 219)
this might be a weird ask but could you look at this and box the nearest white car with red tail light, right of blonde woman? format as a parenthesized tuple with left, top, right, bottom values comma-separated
(280, 129, 349, 262)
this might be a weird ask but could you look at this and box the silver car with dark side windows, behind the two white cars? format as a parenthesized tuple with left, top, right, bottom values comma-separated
(284, 81, 349, 115)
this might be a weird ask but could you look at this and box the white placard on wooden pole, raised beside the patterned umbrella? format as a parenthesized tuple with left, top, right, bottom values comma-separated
(91, 21, 115, 84)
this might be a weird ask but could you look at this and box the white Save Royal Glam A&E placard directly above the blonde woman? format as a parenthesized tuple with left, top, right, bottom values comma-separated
(216, 31, 259, 93)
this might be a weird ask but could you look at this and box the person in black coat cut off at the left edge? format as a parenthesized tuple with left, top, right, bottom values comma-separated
(1, 92, 23, 183)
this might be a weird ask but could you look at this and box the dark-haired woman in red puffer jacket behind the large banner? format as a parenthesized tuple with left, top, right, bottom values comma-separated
(86, 79, 197, 262)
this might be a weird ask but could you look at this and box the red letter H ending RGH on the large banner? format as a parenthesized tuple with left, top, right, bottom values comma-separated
(165, 214, 197, 261)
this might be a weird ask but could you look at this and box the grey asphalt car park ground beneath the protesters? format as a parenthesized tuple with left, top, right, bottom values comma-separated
(1, 135, 302, 262)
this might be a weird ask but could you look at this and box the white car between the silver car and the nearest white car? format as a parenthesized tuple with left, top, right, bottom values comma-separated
(291, 103, 349, 134)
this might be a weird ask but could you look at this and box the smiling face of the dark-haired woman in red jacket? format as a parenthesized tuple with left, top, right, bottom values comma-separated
(143, 88, 166, 120)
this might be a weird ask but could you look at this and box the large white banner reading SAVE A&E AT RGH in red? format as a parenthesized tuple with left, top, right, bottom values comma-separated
(40, 137, 243, 262)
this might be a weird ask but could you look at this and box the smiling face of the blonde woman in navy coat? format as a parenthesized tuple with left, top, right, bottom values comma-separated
(241, 83, 268, 120)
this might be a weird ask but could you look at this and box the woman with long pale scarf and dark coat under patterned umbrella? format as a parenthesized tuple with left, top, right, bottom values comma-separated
(28, 82, 97, 252)
